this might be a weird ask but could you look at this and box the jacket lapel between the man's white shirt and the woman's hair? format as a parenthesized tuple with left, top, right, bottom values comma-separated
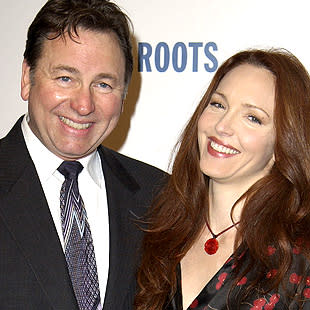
(99, 148, 141, 310)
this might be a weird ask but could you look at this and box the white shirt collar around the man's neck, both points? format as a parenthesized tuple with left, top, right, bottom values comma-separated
(21, 114, 103, 187)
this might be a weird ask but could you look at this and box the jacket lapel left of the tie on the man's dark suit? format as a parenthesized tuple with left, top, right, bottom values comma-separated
(0, 120, 77, 309)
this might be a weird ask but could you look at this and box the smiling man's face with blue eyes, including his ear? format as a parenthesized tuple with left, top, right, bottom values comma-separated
(21, 29, 125, 160)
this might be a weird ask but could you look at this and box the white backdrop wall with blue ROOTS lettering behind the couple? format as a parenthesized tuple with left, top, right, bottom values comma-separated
(0, 0, 310, 170)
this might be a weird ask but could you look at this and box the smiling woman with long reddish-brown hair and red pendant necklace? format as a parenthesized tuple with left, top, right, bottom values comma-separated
(135, 50, 310, 310)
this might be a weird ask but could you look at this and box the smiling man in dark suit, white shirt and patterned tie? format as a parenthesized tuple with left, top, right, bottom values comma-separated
(0, 0, 164, 310)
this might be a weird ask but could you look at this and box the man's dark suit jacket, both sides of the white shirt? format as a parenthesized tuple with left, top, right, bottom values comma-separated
(0, 119, 164, 310)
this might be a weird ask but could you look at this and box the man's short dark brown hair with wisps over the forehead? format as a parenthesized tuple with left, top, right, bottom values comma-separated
(24, 0, 133, 86)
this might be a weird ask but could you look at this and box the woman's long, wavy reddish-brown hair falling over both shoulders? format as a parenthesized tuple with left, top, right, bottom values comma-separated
(135, 50, 310, 310)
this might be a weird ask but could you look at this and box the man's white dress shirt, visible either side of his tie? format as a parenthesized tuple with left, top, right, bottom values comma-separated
(22, 115, 109, 302)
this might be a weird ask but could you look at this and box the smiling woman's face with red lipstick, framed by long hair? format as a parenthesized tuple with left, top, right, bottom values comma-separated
(198, 64, 275, 185)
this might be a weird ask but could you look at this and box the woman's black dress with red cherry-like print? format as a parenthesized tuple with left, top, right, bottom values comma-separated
(165, 246, 310, 310)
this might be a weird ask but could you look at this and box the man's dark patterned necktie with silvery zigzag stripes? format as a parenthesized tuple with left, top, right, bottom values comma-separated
(58, 161, 100, 310)
